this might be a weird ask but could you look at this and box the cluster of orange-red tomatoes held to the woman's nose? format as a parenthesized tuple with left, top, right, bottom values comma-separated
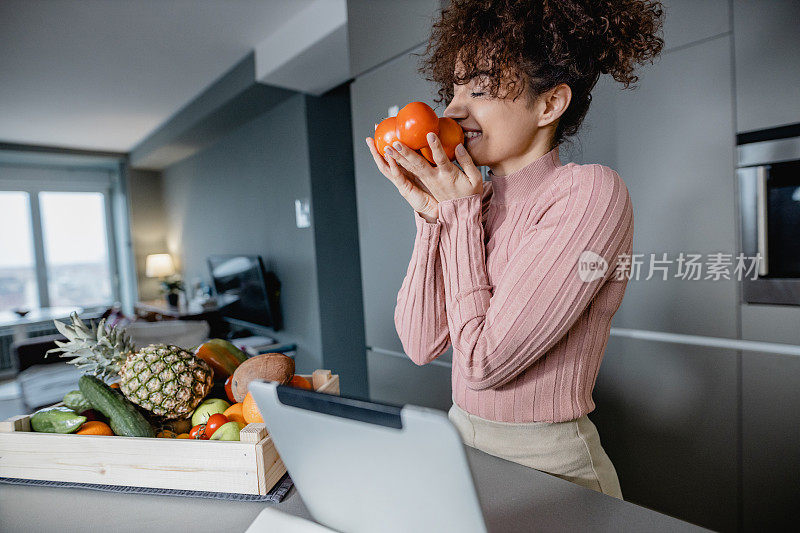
(375, 102, 464, 164)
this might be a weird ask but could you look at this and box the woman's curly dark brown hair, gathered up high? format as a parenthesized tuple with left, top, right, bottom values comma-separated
(419, 0, 664, 147)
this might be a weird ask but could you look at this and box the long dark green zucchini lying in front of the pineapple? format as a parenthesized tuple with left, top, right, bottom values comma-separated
(78, 375, 155, 437)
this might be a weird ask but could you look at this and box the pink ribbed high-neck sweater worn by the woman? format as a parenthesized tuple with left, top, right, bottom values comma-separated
(394, 147, 633, 422)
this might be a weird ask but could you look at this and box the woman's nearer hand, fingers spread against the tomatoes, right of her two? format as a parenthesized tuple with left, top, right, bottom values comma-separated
(386, 133, 483, 206)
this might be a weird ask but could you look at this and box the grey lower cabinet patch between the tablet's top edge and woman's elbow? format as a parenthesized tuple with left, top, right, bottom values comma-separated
(367, 350, 453, 411)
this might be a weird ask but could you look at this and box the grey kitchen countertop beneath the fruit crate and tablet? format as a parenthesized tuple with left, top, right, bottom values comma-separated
(0, 447, 705, 533)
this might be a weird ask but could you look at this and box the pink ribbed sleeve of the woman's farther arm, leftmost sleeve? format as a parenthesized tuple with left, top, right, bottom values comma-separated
(394, 211, 450, 365)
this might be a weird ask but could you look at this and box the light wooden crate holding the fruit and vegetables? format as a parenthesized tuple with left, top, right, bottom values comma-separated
(0, 370, 339, 494)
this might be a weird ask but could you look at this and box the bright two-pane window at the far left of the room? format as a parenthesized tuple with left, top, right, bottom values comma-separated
(0, 167, 119, 311)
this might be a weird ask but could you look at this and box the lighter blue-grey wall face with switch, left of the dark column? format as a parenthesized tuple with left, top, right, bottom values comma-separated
(164, 95, 322, 371)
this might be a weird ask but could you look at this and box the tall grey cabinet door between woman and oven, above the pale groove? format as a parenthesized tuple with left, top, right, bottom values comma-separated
(562, 35, 738, 338)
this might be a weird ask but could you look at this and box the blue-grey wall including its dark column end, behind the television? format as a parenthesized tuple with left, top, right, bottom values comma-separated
(155, 87, 367, 396)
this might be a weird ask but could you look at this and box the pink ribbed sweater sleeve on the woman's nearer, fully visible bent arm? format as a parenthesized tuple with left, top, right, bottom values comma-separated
(439, 165, 633, 390)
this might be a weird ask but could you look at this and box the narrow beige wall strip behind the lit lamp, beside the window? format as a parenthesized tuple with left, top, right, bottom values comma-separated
(128, 169, 167, 300)
